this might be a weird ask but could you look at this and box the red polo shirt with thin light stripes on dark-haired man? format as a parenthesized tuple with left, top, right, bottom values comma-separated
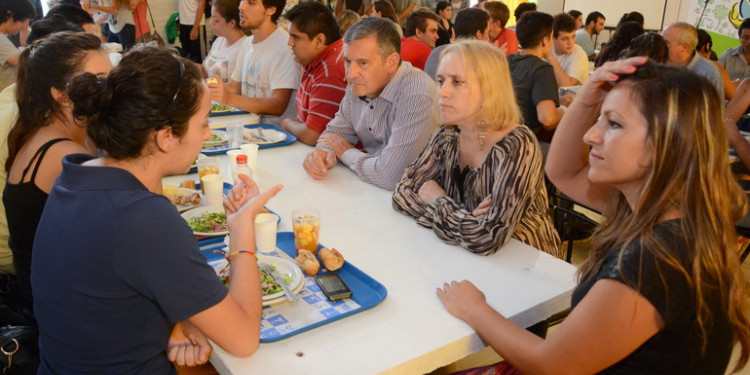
(295, 39, 346, 133)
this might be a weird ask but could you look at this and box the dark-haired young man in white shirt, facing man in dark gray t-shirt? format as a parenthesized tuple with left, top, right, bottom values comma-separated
(547, 13, 589, 87)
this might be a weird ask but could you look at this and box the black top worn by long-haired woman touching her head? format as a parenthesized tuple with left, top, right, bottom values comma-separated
(571, 219, 734, 375)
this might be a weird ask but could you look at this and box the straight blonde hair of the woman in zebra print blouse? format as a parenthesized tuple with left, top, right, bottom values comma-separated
(440, 39, 521, 130)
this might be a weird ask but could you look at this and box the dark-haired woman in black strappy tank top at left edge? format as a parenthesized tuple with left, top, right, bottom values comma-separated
(3, 32, 112, 318)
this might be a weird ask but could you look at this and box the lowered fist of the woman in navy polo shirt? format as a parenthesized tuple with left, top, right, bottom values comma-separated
(167, 321, 212, 366)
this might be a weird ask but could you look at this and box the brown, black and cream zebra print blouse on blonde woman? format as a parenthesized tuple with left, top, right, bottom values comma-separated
(393, 125, 564, 259)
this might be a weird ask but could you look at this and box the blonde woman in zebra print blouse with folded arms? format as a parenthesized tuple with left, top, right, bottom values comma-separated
(393, 40, 563, 258)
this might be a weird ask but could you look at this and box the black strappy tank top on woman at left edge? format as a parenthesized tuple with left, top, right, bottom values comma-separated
(3, 138, 70, 309)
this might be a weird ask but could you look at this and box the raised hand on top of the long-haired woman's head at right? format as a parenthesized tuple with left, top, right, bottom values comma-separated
(572, 56, 648, 107)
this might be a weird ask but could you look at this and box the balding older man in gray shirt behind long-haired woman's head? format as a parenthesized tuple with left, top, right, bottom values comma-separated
(661, 22, 724, 98)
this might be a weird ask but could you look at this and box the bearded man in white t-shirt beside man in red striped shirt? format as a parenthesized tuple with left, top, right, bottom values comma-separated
(209, 0, 302, 124)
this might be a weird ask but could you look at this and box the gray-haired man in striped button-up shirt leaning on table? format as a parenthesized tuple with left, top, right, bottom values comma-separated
(303, 17, 438, 190)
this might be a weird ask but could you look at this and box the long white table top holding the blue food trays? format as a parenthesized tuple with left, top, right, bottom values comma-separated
(173, 143, 576, 374)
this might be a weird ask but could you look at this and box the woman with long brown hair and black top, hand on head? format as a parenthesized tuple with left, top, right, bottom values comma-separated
(437, 57, 750, 374)
